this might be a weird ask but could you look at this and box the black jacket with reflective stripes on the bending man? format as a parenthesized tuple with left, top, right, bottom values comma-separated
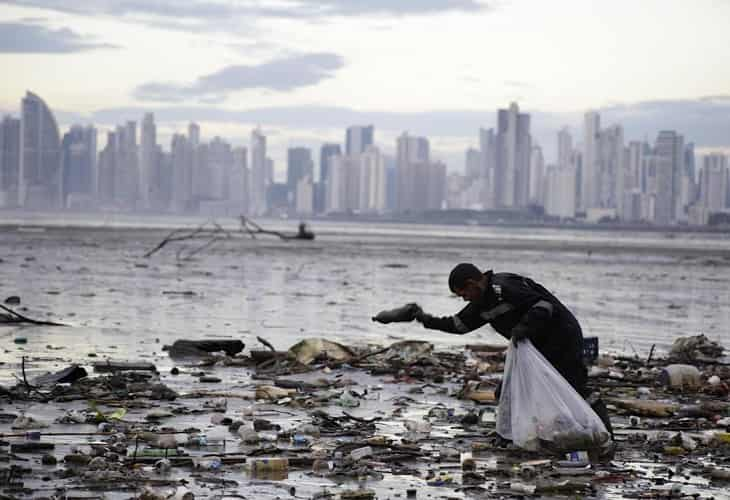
(420, 271, 587, 396)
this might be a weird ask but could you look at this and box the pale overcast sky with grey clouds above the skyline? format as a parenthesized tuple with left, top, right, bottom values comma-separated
(0, 0, 730, 172)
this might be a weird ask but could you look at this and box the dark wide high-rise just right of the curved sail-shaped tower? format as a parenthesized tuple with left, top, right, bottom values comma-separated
(61, 125, 97, 208)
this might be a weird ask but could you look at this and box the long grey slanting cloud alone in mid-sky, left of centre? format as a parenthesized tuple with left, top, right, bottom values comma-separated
(133, 53, 344, 103)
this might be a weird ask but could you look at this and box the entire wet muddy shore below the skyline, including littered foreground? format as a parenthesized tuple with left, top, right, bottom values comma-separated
(0, 220, 730, 499)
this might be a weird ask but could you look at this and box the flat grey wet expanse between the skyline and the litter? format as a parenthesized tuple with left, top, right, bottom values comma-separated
(0, 213, 730, 383)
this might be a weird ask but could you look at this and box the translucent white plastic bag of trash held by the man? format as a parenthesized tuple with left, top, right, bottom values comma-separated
(497, 340, 610, 451)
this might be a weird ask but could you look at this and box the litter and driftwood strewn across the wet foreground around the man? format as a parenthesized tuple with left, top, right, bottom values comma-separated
(0, 336, 730, 500)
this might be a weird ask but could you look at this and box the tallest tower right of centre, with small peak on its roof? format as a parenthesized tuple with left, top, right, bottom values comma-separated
(493, 102, 532, 208)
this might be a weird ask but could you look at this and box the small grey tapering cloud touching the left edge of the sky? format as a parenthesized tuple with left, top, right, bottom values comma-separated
(0, 22, 116, 54)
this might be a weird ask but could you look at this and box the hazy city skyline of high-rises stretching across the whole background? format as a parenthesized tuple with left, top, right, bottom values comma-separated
(0, 91, 730, 226)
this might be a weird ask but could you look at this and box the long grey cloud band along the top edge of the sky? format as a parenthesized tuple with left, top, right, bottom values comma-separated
(0, 0, 487, 31)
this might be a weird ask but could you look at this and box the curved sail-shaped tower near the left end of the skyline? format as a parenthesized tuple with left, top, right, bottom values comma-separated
(18, 92, 63, 209)
